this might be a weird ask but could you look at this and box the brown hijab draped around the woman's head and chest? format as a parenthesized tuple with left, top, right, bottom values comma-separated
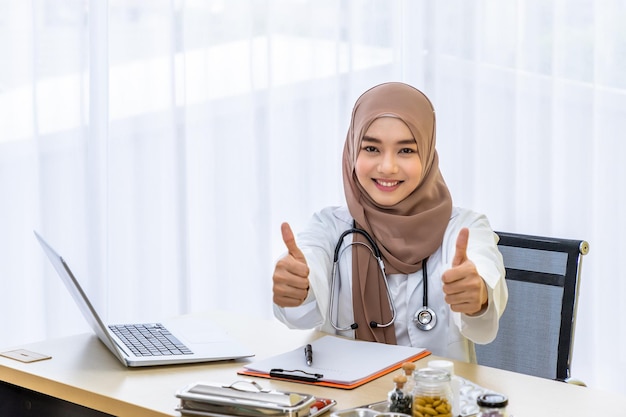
(342, 82, 452, 344)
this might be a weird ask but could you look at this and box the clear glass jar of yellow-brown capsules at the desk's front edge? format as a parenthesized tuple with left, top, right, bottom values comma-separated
(412, 368, 452, 417)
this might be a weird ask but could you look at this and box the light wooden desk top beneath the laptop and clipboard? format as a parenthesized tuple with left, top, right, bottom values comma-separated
(0, 312, 625, 417)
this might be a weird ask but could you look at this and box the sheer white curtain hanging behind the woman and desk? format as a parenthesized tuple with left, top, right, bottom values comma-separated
(0, 0, 626, 393)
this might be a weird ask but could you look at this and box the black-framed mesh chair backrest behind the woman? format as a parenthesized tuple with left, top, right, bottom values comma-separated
(475, 232, 589, 381)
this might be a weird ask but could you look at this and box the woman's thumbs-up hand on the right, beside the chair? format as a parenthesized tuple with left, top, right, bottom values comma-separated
(441, 227, 488, 315)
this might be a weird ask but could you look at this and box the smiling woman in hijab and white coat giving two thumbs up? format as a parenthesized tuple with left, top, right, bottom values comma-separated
(273, 82, 508, 362)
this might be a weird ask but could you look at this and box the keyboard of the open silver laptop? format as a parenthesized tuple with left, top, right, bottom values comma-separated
(109, 323, 193, 356)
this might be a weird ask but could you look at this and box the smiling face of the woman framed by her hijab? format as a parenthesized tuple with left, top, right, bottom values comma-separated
(354, 117, 422, 207)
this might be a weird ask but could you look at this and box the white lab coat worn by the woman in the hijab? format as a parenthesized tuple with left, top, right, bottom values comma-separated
(274, 207, 508, 362)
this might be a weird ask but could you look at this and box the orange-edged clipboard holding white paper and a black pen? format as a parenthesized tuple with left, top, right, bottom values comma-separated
(237, 335, 430, 389)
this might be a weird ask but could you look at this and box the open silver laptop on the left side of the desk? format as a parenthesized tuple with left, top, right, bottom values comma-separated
(35, 231, 254, 367)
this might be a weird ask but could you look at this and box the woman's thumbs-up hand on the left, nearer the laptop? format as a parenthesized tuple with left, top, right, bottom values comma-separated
(272, 223, 309, 307)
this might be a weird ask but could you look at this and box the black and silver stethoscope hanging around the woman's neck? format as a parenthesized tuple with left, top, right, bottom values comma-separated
(328, 225, 437, 331)
